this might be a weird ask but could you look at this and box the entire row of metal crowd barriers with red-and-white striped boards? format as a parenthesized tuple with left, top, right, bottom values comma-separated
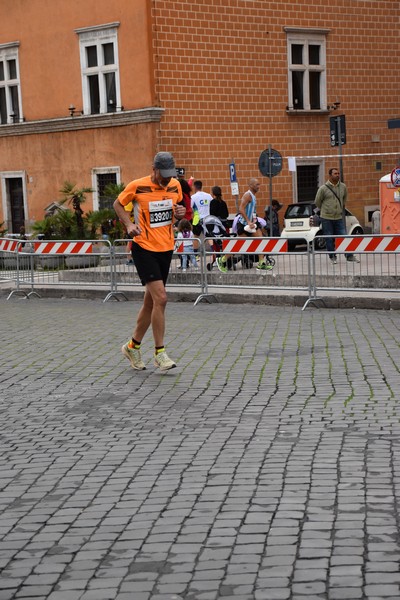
(0, 235, 400, 310)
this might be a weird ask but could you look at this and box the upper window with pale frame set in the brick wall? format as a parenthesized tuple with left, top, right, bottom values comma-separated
(287, 30, 327, 111)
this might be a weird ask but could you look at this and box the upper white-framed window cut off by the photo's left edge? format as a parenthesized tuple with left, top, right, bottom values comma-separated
(0, 42, 23, 125)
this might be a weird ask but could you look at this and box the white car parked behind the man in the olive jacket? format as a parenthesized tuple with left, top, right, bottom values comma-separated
(281, 202, 364, 250)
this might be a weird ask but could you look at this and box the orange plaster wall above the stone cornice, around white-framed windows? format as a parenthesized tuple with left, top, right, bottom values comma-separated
(0, 0, 154, 120)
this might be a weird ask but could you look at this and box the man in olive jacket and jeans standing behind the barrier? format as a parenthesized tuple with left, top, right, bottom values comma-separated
(315, 168, 359, 265)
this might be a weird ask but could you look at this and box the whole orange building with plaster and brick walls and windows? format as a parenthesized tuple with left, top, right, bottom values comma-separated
(0, 0, 400, 230)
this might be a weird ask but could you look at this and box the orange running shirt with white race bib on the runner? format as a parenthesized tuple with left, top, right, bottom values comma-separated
(118, 175, 182, 252)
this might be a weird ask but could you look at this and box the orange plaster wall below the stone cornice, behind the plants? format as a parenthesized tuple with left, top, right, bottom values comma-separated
(0, 123, 156, 228)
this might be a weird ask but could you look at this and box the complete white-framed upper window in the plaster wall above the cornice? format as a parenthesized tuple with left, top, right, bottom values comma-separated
(76, 23, 122, 115)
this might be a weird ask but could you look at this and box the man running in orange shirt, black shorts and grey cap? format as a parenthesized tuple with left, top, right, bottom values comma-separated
(114, 152, 186, 371)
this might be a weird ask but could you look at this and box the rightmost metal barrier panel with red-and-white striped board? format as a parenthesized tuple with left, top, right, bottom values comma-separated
(311, 234, 400, 310)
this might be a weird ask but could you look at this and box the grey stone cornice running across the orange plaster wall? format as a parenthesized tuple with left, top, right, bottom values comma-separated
(0, 106, 164, 137)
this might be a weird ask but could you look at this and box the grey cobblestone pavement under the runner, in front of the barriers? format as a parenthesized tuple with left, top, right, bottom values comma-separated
(0, 299, 400, 600)
